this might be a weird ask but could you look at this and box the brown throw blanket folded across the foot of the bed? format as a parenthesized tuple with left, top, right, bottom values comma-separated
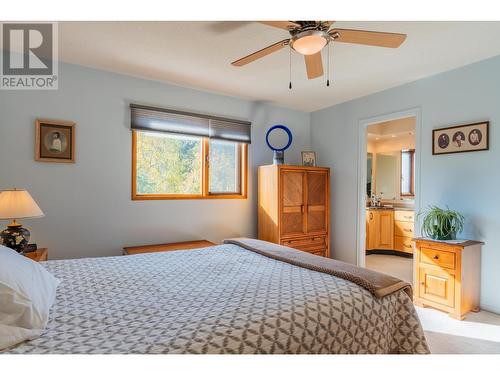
(224, 237, 413, 298)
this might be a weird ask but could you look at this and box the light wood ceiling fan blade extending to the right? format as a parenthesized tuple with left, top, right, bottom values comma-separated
(328, 29, 406, 48)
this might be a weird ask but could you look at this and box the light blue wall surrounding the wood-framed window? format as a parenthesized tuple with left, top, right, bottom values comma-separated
(0, 64, 310, 259)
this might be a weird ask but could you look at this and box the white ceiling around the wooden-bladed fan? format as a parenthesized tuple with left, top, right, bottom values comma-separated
(59, 22, 500, 111)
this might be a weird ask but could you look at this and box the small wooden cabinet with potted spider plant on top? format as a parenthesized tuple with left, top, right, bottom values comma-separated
(414, 238, 483, 319)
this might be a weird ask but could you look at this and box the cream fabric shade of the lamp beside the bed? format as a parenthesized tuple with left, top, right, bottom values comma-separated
(0, 189, 45, 220)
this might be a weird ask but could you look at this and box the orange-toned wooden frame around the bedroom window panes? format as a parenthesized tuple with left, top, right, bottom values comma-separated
(132, 130, 248, 201)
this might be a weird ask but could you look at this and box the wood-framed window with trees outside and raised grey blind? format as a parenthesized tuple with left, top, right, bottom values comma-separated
(132, 104, 248, 200)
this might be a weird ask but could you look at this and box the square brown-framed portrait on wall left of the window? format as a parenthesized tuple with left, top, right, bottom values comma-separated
(35, 119, 75, 163)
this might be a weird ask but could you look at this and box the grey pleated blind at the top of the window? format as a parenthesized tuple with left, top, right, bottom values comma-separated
(130, 104, 251, 143)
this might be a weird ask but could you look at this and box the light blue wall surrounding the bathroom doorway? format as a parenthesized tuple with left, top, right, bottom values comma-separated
(311, 57, 500, 312)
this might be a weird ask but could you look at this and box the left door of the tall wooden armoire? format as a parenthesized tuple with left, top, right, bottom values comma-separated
(281, 170, 306, 235)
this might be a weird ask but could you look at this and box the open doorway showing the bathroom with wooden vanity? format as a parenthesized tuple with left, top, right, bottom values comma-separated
(357, 109, 420, 284)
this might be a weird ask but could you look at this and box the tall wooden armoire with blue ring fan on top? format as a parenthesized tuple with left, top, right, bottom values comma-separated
(259, 165, 330, 257)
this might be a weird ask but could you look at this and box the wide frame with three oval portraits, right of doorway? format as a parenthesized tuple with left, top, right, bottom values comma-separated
(432, 121, 490, 155)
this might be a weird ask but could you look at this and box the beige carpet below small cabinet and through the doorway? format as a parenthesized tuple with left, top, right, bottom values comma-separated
(366, 254, 500, 354)
